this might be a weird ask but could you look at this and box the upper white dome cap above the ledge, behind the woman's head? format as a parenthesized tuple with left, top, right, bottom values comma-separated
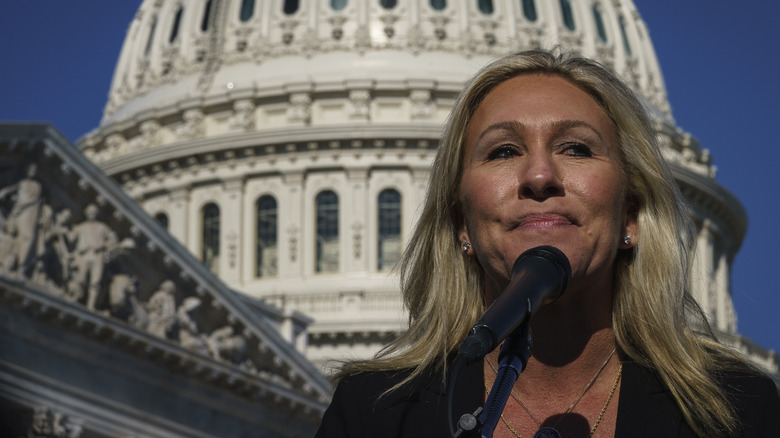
(97, 0, 669, 127)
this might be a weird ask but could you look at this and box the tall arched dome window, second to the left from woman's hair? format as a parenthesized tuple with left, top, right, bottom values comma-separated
(315, 190, 339, 272)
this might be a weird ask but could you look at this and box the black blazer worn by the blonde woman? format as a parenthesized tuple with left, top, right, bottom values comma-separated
(315, 361, 780, 438)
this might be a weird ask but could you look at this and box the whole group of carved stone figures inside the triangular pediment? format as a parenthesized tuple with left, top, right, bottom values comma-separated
(0, 164, 253, 369)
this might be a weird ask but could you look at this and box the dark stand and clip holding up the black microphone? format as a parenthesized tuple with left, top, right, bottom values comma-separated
(454, 322, 532, 438)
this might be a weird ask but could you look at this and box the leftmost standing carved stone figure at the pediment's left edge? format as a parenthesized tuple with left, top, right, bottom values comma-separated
(0, 163, 43, 277)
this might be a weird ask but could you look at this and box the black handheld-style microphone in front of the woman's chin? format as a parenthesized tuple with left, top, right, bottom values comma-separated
(458, 246, 571, 364)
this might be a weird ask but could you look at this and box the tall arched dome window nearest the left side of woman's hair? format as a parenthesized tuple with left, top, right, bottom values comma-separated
(377, 189, 401, 271)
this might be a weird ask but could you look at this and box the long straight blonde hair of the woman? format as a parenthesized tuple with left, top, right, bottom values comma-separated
(341, 50, 749, 436)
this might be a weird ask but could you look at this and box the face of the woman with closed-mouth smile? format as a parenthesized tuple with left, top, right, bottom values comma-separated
(459, 75, 636, 302)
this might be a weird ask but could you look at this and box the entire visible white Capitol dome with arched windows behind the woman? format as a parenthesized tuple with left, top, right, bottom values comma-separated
(78, 0, 746, 369)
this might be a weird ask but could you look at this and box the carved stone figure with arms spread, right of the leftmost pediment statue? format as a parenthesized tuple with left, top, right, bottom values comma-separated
(71, 204, 117, 310)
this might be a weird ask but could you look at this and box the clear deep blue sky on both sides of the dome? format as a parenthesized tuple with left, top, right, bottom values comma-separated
(0, 0, 780, 351)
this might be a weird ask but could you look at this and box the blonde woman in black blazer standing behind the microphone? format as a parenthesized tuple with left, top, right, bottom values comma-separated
(318, 51, 780, 437)
